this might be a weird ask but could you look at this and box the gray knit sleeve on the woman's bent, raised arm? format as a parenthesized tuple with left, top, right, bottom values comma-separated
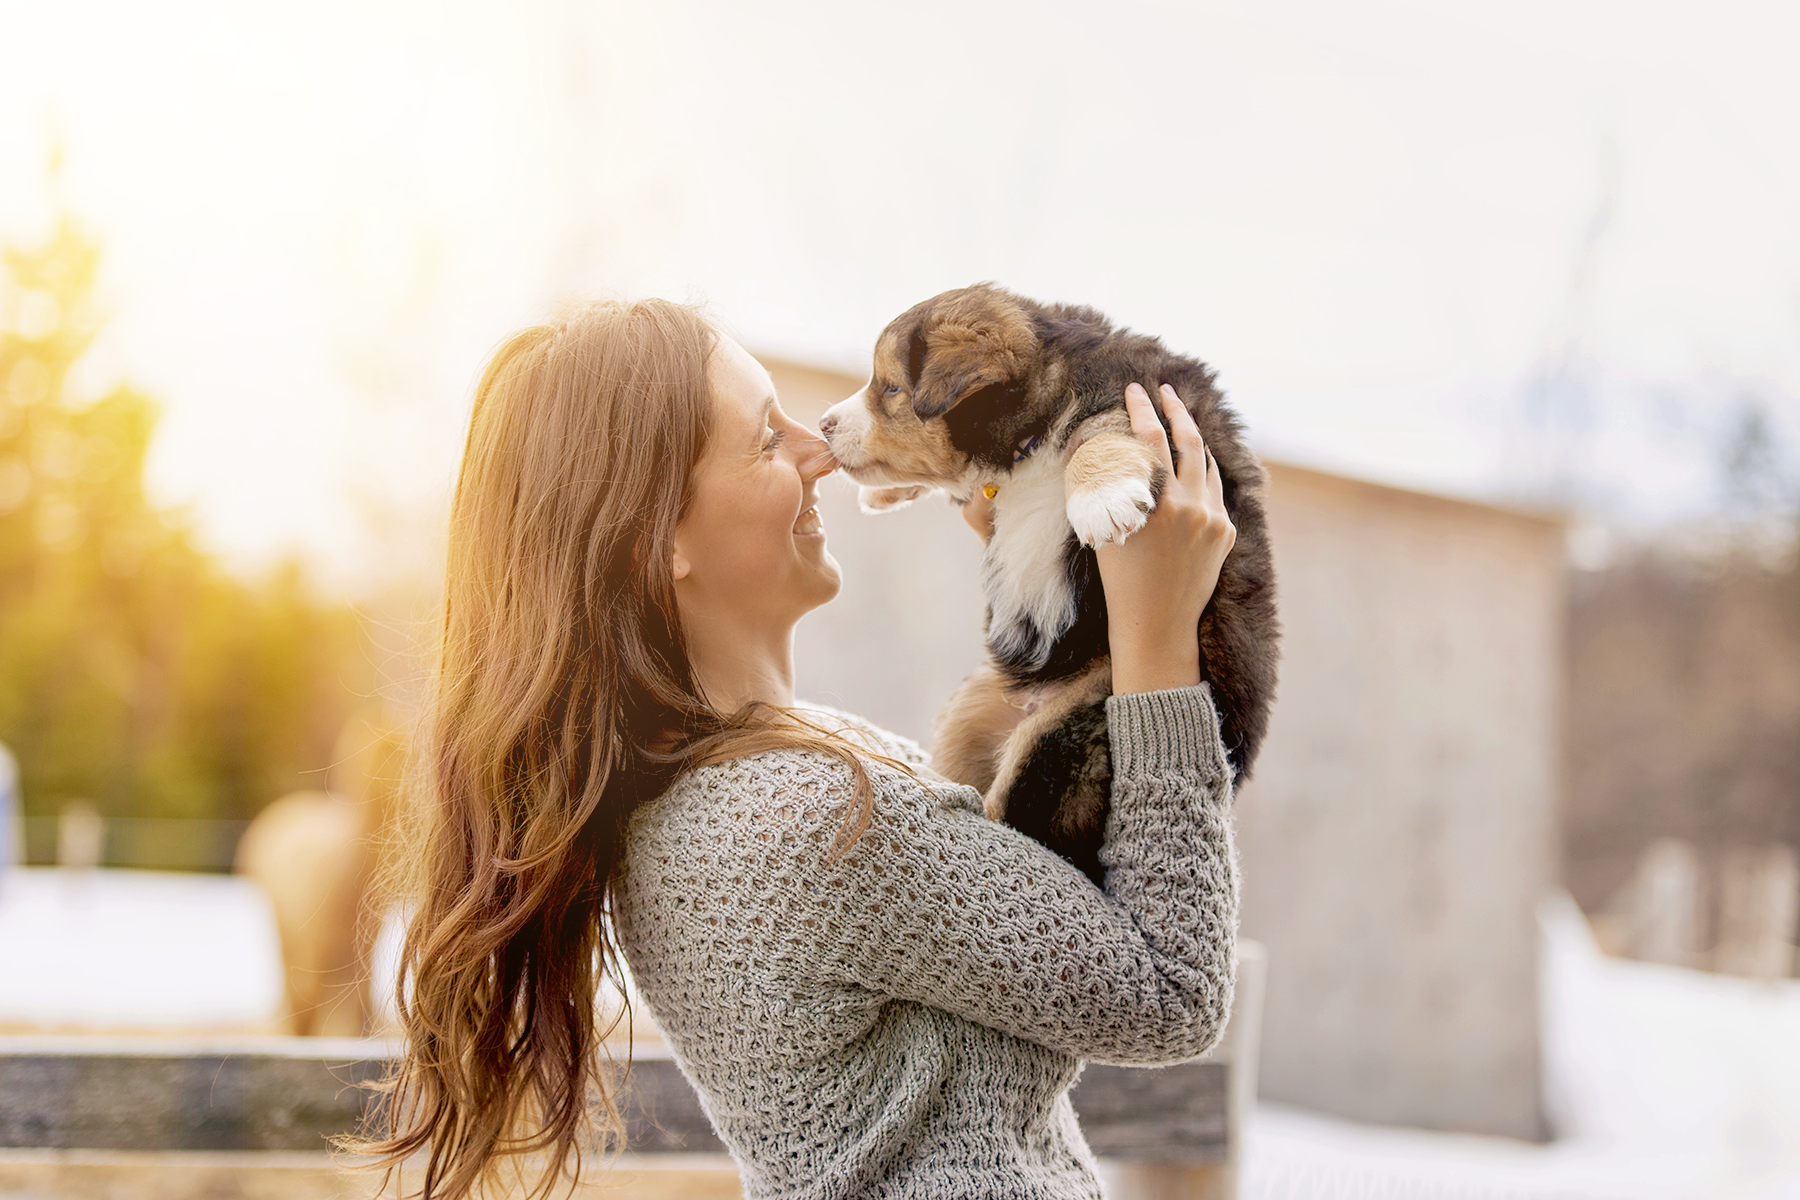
(765, 685, 1237, 1063)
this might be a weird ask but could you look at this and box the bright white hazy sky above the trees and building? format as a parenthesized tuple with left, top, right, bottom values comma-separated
(0, 0, 1800, 579)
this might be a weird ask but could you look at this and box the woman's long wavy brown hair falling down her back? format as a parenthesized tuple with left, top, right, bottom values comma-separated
(351, 300, 873, 1200)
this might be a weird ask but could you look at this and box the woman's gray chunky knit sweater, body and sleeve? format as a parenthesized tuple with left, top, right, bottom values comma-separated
(616, 685, 1237, 1200)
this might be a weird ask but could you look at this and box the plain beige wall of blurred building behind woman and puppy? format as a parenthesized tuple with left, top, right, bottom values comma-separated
(765, 360, 1562, 1137)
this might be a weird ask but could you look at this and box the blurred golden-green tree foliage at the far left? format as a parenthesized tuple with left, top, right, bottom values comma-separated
(0, 214, 371, 819)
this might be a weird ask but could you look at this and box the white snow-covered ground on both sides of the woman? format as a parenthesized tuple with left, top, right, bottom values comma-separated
(0, 869, 1800, 1200)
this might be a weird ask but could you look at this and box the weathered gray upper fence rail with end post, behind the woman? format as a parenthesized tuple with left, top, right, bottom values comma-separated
(0, 945, 1264, 1196)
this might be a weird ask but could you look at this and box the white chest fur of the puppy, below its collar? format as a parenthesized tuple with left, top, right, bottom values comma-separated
(983, 453, 1075, 667)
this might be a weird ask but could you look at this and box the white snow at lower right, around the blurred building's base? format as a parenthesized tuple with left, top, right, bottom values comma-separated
(1242, 894, 1800, 1200)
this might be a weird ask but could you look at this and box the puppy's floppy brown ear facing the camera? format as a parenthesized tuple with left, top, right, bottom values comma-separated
(907, 288, 1037, 419)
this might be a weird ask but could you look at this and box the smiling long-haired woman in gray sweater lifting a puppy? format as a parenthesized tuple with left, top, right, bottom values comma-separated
(369, 300, 1237, 1198)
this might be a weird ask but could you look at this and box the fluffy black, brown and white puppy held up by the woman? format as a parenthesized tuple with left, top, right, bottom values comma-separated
(819, 284, 1278, 882)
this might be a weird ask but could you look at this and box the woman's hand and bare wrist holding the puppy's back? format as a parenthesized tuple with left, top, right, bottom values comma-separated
(1094, 383, 1237, 694)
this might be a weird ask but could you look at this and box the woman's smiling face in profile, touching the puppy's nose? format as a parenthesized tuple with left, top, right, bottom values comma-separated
(675, 336, 842, 631)
